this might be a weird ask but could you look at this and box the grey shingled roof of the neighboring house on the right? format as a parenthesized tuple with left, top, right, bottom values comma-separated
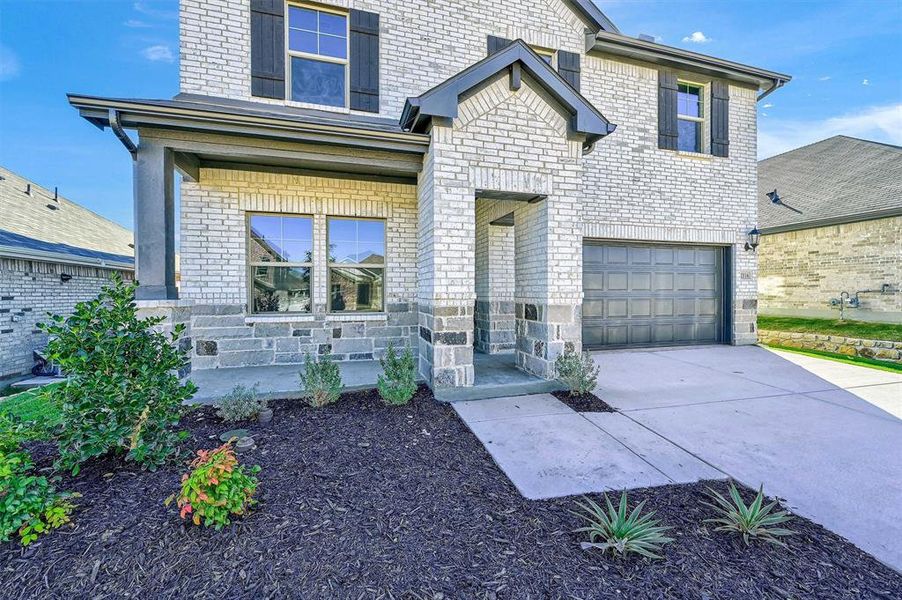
(758, 135, 902, 233)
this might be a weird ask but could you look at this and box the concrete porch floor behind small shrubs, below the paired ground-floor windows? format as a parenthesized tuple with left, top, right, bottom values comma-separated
(188, 360, 382, 404)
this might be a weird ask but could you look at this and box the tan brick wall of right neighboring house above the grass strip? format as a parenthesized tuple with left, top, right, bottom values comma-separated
(758, 217, 902, 321)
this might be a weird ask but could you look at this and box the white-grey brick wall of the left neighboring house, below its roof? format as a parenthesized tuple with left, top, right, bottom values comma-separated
(0, 258, 131, 377)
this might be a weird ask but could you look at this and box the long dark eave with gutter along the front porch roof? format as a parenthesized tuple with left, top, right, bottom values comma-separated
(68, 94, 429, 154)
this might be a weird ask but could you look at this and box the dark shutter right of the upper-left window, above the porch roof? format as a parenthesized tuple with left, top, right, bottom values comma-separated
(350, 10, 379, 112)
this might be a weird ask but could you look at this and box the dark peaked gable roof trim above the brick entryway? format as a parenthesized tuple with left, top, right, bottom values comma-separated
(401, 40, 617, 147)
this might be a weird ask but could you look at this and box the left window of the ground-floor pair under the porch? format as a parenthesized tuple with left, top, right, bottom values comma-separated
(248, 214, 313, 314)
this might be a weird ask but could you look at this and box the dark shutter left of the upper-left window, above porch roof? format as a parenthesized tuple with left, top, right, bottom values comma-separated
(251, 0, 285, 99)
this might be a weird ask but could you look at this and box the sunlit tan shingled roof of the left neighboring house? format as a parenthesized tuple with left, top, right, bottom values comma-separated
(0, 167, 134, 268)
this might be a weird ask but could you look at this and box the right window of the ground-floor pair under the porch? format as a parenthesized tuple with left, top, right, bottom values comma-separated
(329, 217, 385, 312)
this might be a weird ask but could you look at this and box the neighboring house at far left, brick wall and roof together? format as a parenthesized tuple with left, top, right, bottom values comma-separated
(0, 167, 135, 378)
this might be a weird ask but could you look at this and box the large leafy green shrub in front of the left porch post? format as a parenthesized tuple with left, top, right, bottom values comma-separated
(39, 276, 196, 474)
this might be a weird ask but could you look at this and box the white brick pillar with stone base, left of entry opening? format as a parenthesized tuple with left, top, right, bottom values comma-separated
(417, 123, 476, 388)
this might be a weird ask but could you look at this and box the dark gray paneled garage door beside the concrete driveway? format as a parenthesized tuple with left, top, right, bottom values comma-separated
(583, 241, 723, 348)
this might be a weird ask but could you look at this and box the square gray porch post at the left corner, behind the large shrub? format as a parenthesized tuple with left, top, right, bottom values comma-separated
(134, 138, 178, 300)
